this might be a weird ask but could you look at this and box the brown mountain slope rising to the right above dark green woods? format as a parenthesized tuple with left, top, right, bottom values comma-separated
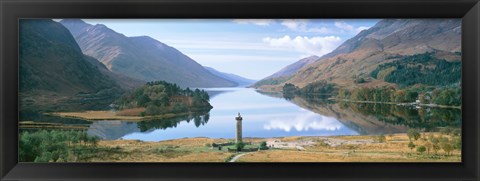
(258, 19, 461, 89)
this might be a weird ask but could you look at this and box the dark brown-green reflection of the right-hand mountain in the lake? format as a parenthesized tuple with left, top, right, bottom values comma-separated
(291, 96, 462, 134)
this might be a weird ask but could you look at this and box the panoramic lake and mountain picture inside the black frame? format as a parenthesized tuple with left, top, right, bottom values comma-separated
(19, 19, 462, 162)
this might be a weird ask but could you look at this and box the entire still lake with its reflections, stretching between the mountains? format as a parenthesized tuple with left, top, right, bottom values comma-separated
(21, 88, 462, 141)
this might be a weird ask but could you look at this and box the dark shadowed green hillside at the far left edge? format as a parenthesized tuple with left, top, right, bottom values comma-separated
(19, 19, 123, 111)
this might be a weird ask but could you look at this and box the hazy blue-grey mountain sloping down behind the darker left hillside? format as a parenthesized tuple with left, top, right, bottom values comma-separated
(60, 19, 236, 87)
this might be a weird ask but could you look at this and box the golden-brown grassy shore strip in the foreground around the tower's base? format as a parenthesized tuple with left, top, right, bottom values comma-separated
(90, 133, 461, 162)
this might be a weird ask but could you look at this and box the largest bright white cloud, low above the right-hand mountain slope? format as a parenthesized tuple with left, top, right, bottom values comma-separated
(263, 35, 342, 56)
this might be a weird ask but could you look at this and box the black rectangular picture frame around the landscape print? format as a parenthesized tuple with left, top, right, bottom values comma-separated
(0, 0, 480, 181)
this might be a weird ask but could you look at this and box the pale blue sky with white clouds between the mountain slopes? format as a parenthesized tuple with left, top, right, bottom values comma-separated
(79, 19, 379, 80)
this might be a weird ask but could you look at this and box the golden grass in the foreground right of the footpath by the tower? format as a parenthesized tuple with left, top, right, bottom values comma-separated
(237, 133, 461, 162)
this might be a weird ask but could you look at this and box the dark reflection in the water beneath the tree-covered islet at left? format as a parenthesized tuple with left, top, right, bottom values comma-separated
(87, 113, 210, 140)
